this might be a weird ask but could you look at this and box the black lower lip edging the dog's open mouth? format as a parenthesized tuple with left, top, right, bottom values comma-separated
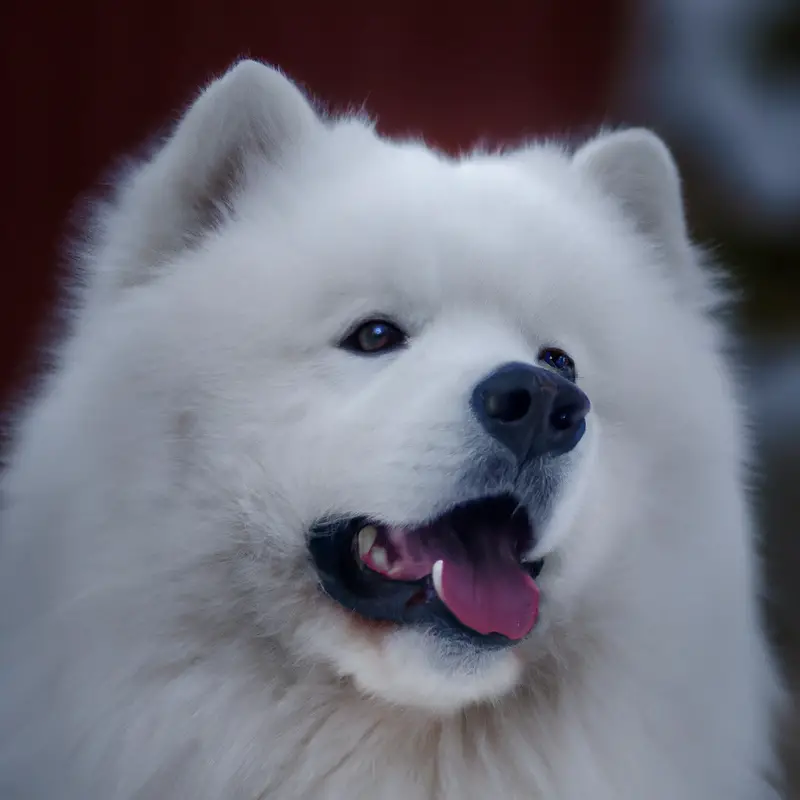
(308, 498, 543, 649)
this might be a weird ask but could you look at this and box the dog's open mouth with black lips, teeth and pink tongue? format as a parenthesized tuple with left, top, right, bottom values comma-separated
(309, 495, 542, 646)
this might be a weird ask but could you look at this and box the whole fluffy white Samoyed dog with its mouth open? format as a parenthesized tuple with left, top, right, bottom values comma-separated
(0, 61, 780, 800)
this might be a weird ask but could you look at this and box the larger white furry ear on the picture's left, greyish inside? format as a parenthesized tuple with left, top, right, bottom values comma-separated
(86, 61, 322, 304)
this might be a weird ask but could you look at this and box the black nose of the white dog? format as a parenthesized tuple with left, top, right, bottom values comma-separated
(472, 363, 590, 462)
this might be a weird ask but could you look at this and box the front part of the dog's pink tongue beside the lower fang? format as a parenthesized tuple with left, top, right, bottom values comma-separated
(440, 553, 539, 639)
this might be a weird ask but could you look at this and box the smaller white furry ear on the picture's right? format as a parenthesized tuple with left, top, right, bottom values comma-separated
(572, 128, 717, 308)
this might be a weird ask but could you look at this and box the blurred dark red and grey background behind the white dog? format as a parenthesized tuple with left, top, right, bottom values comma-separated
(0, 0, 800, 788)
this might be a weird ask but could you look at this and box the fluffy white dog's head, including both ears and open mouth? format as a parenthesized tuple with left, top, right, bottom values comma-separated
(72, 62, 736, 709)
